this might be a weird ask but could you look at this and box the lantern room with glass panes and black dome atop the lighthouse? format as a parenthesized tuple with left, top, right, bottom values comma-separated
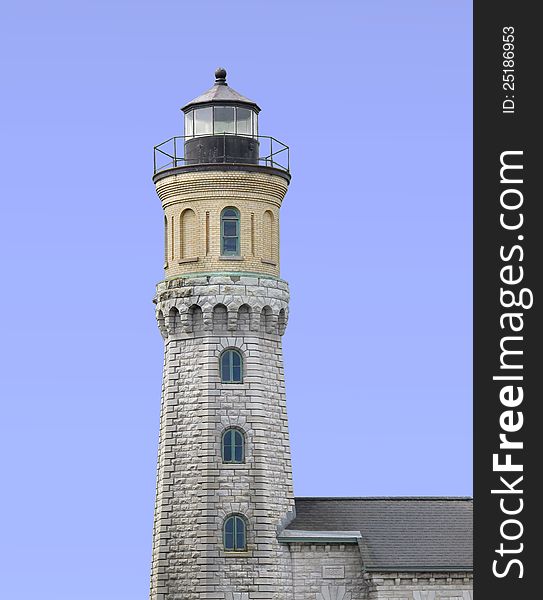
(182, 68, 260, 164)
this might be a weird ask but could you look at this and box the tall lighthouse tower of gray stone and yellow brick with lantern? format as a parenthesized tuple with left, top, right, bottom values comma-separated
(151, 69, 294, 600)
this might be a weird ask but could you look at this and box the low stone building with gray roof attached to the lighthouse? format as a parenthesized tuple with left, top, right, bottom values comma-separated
(279, 497, 473, 600)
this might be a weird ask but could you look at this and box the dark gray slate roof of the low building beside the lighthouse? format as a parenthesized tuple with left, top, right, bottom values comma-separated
(287, 497, 473, 571)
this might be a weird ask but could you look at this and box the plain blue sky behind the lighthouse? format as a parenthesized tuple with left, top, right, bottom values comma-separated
(0, 0, 472, 600)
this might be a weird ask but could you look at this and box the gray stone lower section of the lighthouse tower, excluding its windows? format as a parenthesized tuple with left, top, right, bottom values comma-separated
(151, 277, 294, 600)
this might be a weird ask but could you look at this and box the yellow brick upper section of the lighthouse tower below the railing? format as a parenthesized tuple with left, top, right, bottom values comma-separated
(155, 165, 290, 279)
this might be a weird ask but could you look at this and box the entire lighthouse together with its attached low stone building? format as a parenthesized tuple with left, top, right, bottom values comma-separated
(151, 69, 472, 600)
